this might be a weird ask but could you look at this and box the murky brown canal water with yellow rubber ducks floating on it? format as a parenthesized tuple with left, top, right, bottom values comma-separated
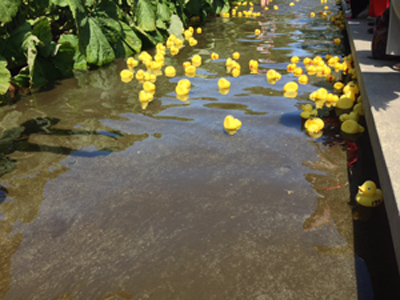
(0, 0, 390, 300)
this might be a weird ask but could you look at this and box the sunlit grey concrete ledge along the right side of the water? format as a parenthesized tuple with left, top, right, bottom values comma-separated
(346, 19, 400, 271)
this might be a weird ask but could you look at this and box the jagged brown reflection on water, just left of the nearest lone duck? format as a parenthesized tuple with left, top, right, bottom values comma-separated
(303, 141, 354, 257)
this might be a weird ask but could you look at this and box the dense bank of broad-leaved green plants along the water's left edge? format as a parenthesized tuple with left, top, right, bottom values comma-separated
(0, 0, 229, 95)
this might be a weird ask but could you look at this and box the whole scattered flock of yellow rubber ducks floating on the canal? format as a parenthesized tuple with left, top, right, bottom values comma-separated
(120, 0, 382, 207)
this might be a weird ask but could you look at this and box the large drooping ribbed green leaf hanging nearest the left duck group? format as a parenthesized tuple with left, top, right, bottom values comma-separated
(79, 17, 115, 66)
